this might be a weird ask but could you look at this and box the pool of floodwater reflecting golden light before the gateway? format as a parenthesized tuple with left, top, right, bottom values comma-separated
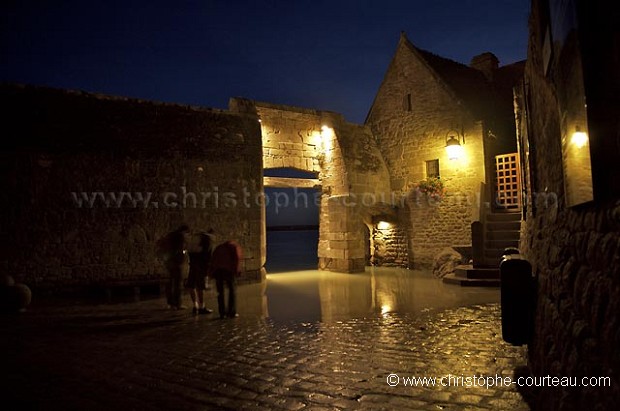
(249, 267, 499, 322)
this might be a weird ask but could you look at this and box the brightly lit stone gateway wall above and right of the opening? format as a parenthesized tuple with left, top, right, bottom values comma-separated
(231, 99, 389, 272)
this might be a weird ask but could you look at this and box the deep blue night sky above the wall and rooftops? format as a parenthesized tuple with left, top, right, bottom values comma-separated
(0, 0, 529, 123)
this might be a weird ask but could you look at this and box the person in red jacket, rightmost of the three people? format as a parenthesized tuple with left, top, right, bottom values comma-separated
(209, 240, 243, 318)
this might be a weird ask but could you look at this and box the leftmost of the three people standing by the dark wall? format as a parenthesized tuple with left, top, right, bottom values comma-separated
(158, 224, 189, 310)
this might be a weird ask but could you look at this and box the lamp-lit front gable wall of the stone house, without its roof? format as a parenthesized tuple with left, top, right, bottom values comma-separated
(367, 37, 486, 268)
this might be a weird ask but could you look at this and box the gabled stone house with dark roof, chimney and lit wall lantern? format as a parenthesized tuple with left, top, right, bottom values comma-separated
(366, 33, 524, 268)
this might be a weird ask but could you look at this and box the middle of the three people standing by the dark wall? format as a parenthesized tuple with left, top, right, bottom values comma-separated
(185, 229, 215, 314)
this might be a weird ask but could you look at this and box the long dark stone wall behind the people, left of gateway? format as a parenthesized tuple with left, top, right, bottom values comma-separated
(0, 86, 262, 287)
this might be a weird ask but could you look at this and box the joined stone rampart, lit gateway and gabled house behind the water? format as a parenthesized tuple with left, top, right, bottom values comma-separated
(0, 34, 522, 288)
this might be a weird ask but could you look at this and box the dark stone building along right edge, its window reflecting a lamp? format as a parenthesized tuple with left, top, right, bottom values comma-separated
(516, 0, 620, 410)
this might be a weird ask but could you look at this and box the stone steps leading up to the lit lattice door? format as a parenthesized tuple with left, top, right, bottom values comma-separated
(443, 212, 521, 287)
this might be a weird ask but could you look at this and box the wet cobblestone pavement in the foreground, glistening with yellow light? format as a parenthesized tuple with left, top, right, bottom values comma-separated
(0, 270, 528, 410)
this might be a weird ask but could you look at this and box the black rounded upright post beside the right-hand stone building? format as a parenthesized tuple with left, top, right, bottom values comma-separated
(499, 249, 535, 345)
